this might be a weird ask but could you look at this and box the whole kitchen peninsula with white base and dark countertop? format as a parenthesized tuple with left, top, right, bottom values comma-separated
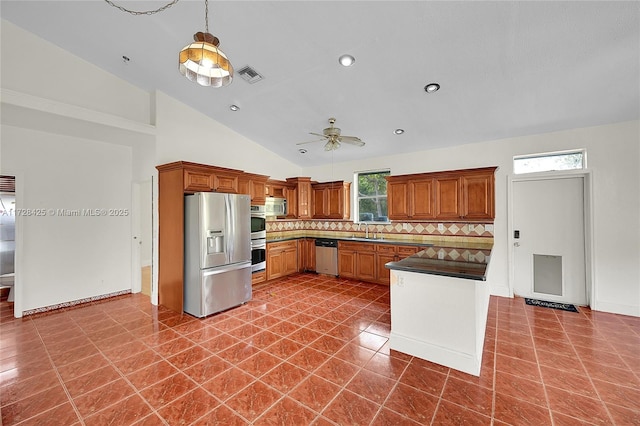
(386, 244, 491, 376)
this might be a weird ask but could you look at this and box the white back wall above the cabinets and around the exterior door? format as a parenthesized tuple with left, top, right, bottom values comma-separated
(302, 121, 640, 316)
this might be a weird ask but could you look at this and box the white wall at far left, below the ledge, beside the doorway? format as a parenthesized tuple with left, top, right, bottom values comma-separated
(0, 125, 132, 310)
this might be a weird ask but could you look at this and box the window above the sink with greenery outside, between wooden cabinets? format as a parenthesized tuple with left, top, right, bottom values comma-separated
(353, 170, 390, 222)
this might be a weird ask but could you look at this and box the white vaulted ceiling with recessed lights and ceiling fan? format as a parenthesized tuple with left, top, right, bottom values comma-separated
(0, 0, 640, 167)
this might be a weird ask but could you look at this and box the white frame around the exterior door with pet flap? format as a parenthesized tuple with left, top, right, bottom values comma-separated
(507, 169, 596, 309)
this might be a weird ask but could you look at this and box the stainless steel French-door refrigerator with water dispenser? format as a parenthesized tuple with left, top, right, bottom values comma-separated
(184, 192, 251, 318)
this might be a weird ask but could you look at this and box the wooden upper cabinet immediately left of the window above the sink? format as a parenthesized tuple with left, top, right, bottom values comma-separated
(311, 181, 351, 219)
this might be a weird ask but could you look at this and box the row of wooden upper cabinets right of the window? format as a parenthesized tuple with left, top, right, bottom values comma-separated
(386, 167, 496, 221)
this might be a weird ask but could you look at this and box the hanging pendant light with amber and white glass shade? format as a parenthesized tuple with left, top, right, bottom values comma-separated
(179, 0, 233, 87)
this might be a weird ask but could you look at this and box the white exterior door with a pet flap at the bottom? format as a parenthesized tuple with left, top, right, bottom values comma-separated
(510, 176, 587, 305)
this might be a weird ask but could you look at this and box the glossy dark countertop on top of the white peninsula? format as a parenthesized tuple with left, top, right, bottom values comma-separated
(385, 246, 491, 281)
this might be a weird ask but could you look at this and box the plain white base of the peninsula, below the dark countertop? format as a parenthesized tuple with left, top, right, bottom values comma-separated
(390, 270, 490, 376)
